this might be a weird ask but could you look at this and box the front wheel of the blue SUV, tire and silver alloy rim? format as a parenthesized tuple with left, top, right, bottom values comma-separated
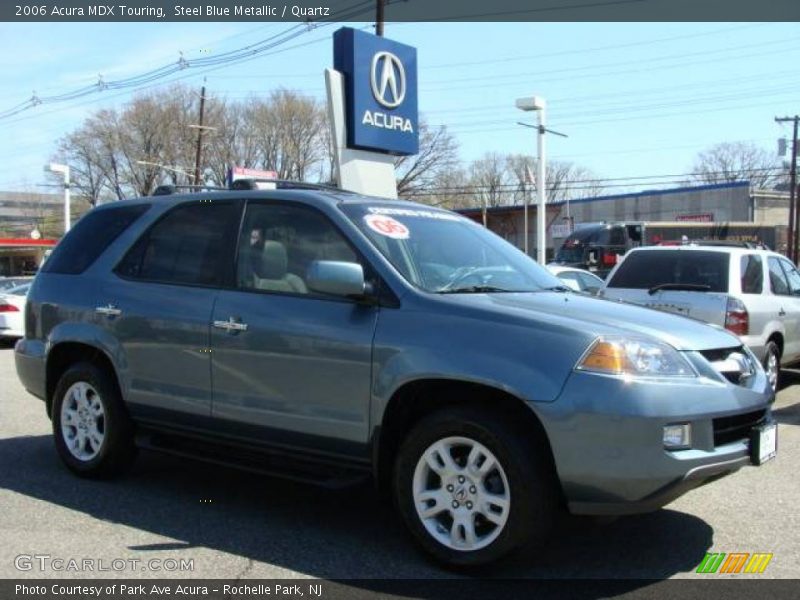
(395, 408, 556, 566)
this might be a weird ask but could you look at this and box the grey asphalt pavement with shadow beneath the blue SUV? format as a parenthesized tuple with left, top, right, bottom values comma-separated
(0, 344, 800, 579)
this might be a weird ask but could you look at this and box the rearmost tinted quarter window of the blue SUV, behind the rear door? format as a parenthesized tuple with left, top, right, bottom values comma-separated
(42, 204, 150, 275)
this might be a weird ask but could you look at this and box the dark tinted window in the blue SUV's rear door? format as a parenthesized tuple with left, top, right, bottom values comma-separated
(116, 201, 239, 286)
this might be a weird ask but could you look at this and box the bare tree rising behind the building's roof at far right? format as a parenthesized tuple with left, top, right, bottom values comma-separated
(690, 142, 786, 188)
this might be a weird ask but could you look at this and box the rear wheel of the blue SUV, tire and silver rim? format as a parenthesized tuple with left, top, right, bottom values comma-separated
(52, 363, 136, 478)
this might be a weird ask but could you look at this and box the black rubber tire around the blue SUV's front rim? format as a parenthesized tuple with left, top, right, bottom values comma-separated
(394, 406, 558, 567)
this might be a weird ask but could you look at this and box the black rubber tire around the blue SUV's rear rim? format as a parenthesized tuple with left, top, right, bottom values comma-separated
(52, 363, 136, 479)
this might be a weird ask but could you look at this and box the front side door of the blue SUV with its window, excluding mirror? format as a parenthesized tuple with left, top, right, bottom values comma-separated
(211, 201, 378, 450)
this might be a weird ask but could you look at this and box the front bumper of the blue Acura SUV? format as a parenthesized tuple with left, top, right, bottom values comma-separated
(533, 356, 774, 515)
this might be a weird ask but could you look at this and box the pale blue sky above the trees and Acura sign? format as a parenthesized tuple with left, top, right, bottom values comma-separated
(0, 22, 800, 192)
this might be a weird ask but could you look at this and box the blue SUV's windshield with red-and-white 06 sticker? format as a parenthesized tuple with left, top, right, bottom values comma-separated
(342, 204, 565, 293)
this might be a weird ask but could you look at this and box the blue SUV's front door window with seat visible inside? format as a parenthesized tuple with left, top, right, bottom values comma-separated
(236, 203, 361, 294)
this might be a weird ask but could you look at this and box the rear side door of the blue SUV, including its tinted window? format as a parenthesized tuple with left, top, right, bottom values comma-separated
(108, 201, 241, 424)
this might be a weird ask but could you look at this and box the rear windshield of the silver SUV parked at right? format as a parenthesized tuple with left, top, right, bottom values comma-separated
(608, 250, 730, 292)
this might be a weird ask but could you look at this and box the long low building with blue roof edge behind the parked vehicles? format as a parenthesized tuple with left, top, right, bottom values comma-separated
(460, 181, 789, 255)
